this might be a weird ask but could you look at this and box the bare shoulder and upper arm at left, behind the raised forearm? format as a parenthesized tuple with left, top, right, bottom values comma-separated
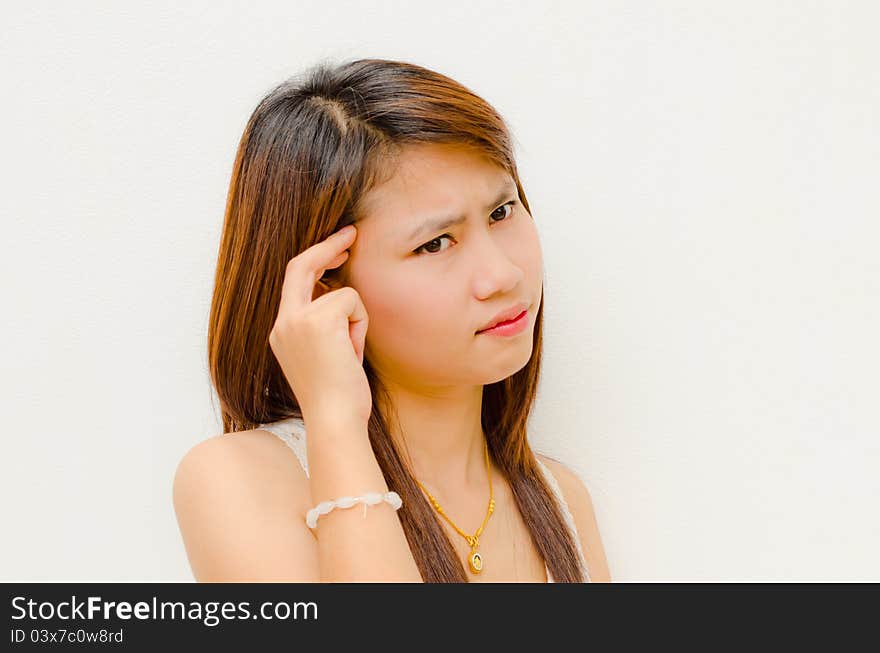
(172, 429, 314, 581)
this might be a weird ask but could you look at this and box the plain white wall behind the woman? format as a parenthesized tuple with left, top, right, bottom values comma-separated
(0, 0, 880, 581)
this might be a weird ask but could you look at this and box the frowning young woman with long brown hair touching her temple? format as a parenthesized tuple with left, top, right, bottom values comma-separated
(174, 59, 611, 583)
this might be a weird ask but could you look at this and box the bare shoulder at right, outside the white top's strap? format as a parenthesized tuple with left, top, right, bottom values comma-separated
(535, 454, 611, 582)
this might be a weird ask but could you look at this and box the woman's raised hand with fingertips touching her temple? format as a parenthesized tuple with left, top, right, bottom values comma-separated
(269, 226, 373, 424)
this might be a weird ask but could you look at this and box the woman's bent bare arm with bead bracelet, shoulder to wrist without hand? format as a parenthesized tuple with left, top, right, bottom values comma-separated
(173, 419, 422, 582)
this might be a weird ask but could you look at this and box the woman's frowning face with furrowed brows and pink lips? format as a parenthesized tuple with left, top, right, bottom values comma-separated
(341, 144, 543, 389)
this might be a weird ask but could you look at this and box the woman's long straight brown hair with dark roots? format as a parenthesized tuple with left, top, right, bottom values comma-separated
(208, 59, 584, 583)
